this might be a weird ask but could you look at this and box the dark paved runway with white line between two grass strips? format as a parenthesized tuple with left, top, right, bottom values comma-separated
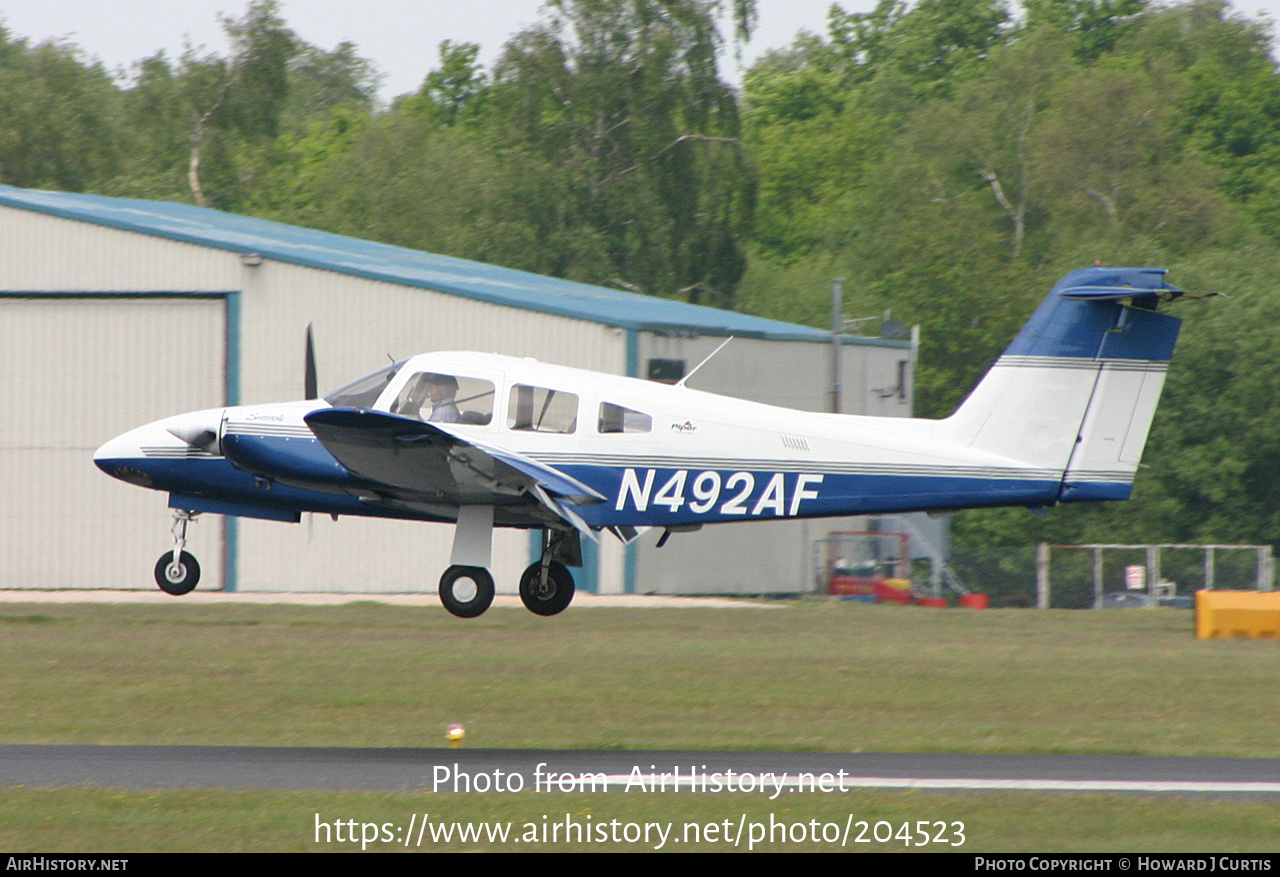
(0, 745, 1280, 798)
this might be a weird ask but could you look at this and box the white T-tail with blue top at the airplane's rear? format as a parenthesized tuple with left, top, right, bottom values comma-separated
(938, 268, 1184, 502)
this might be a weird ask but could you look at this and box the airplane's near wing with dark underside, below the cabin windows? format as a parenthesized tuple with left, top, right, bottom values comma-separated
(305, 408, 605, 533)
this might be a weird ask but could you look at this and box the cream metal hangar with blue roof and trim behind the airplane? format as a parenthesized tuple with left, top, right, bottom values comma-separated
(0, 186, 915, 593)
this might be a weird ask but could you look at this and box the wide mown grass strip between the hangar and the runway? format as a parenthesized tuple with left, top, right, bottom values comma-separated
(0, 600, 1280, 757)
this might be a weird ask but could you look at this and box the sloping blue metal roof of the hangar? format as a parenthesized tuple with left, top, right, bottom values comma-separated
(0, 186, 901, 347)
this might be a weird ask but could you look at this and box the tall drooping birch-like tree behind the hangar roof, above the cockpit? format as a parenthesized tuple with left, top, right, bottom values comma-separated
(490, 0, 754, 305)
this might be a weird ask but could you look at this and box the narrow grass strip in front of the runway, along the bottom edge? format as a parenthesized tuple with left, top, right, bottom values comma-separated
(0, 789, 1280, 850)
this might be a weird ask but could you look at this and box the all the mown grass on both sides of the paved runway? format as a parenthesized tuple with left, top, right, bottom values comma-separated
(0, 600, 1280, 850)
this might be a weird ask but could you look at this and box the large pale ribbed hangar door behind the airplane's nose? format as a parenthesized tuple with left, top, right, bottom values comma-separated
(0, 296, 227, 589)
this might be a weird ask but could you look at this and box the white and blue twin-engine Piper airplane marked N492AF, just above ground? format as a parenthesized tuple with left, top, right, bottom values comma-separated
(93, 268, 1184, 618)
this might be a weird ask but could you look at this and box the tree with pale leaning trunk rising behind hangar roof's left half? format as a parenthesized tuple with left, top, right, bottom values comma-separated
(110, 0, 379, 213)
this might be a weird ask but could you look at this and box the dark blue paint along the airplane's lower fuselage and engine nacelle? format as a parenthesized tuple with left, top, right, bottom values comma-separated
(99, 434, 1132, 527)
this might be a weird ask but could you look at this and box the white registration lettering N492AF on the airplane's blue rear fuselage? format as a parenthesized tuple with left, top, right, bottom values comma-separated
(614, 469, 823, 517)
